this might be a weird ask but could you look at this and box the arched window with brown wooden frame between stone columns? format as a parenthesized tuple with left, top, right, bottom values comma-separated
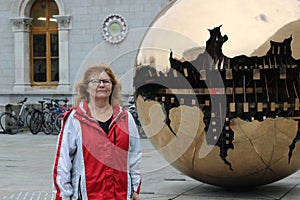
(30, 0, 59, 86)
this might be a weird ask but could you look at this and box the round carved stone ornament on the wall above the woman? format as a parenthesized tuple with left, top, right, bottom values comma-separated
(102, 14, 128, 44)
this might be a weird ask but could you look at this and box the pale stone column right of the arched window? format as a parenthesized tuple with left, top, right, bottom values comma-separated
(53, 15, 71, 91)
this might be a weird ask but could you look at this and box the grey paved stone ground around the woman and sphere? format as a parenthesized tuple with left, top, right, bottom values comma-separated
(0, 132, 300, 200)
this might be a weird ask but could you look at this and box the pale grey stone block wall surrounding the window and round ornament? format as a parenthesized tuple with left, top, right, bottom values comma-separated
(0, 0, 170, 108)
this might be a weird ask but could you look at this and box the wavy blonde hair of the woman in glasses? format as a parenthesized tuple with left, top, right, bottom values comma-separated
(75, 64, 123, 105)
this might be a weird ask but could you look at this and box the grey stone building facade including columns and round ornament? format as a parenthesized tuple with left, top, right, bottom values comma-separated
(0, 0, 170, 109)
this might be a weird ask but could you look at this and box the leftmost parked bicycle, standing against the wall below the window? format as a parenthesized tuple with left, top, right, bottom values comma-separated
(0, 98, 31, 134)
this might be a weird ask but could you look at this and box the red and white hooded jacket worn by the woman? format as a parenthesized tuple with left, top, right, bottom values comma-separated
(53, 101, 142, 200)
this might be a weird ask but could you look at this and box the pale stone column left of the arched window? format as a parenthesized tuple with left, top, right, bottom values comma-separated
(10, 17, 32, 91)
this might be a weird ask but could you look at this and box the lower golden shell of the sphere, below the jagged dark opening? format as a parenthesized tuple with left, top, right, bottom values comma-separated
(137, 97, 300, 187)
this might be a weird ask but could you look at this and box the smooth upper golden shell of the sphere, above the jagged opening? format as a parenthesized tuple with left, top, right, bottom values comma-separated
(136, 0, 300, 69)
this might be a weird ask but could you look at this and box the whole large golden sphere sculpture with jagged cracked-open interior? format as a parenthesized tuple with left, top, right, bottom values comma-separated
(134, 0, 300, 187)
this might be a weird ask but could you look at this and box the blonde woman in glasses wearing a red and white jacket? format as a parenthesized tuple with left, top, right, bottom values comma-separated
(53, 65, 142, 200)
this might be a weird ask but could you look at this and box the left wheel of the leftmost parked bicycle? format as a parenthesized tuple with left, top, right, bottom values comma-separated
(0, 112, 19, 135)
